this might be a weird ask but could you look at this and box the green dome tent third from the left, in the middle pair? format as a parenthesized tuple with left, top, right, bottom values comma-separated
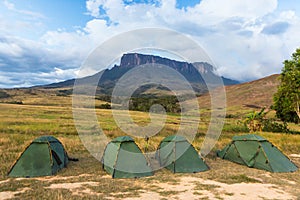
(156, 135, 209, 173)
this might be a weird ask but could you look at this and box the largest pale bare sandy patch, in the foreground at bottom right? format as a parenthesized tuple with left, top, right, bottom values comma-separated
(126, 177, 296, 200)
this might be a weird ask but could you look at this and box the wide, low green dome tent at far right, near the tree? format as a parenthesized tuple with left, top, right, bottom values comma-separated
(217, 134, 298, 172)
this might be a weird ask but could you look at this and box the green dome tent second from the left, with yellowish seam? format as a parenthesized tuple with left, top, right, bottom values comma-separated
(102, 136, 153, 178)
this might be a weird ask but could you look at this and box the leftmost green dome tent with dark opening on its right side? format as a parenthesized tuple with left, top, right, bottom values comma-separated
(8, 136, 69, 177)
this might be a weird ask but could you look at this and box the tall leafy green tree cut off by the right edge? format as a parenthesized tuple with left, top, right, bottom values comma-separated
(273, 49, 300, 123)
